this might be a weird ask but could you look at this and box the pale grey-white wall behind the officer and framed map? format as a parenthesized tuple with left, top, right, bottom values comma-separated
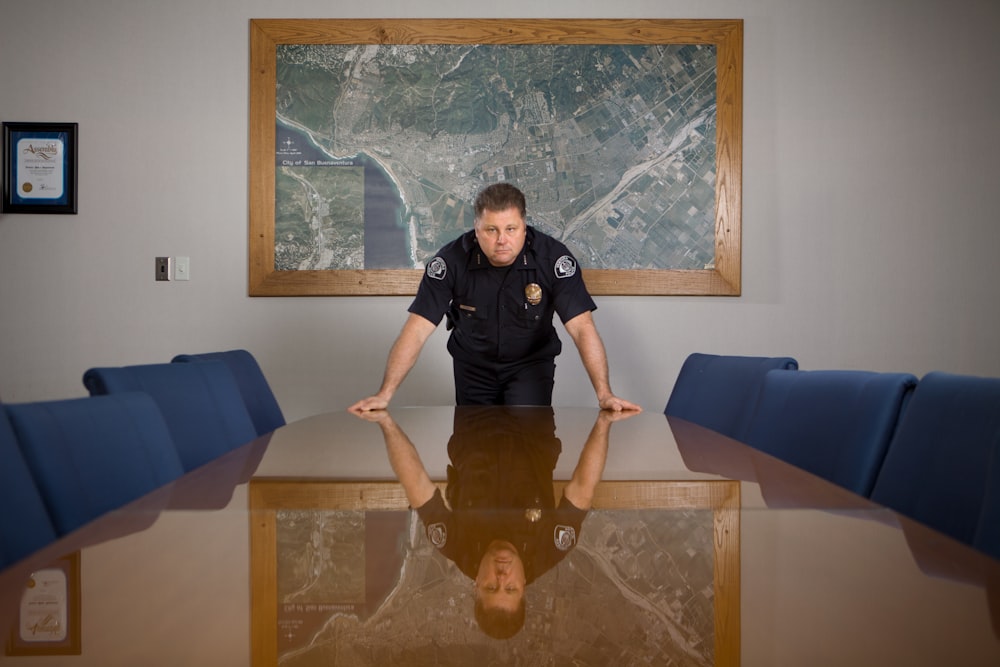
(0, 0, 1000, 419)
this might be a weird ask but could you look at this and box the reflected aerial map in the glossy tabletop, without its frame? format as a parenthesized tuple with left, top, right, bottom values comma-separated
(277, 509, 716, 667)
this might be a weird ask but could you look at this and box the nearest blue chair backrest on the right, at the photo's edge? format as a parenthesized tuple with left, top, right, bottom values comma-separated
(871, 372, 1000, 544)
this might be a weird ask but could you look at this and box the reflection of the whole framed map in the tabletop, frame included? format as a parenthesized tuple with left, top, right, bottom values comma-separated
(248, 478, 740, 667)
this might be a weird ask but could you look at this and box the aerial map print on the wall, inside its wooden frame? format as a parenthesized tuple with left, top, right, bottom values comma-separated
(275, 44, 716, 270)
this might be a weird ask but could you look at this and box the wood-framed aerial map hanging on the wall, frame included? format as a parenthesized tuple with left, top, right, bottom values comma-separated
(249, 19, 743, 296)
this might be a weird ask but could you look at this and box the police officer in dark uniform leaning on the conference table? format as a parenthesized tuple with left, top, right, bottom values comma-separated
(349, 183, 641, 412)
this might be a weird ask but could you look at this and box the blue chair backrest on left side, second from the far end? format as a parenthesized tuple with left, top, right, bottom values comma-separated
(83, 361, 257, 470)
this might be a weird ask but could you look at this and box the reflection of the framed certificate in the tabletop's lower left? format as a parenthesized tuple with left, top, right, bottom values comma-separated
(7, 551, 82, 655)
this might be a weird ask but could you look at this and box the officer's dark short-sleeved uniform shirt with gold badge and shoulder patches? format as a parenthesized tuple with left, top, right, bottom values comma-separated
(409, 227, 597, 363)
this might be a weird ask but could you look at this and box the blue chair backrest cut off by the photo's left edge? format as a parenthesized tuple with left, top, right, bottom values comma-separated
(0, 404, 56, 569)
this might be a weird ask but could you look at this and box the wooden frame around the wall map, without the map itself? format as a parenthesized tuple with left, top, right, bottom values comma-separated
(249, 19, 743, 296)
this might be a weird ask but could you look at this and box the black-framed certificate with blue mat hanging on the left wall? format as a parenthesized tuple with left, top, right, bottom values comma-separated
(0, 122, 78, 214)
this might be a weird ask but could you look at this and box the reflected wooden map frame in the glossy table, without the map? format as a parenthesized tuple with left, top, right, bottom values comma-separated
(249, 478, 740, 667)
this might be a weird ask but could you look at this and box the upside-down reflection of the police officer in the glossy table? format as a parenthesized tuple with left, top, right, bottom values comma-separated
(361, 406, 635, 639)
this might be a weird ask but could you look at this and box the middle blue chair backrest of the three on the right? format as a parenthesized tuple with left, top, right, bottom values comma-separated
(744, 370, 917, 497)
